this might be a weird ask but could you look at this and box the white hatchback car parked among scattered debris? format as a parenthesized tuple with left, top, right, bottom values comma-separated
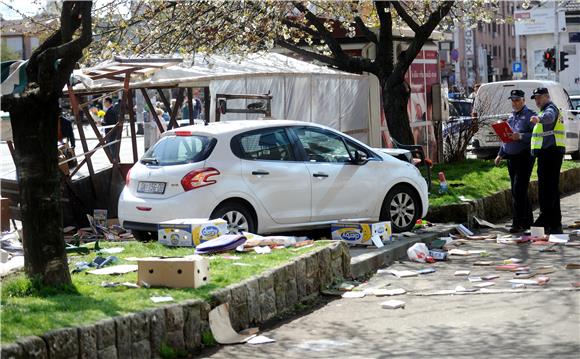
(118, 120, 428, 239)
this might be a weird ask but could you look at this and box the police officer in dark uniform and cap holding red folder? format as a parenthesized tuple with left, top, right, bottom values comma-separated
(495, 90, 536, 233)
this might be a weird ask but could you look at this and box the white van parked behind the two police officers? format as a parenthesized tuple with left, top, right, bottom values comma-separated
(471, 80, 580, 160)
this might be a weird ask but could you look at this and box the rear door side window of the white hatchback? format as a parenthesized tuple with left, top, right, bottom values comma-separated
(240, 128, 294, 161)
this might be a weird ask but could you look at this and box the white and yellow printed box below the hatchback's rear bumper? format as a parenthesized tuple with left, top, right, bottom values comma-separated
(157, 218, 228, 247)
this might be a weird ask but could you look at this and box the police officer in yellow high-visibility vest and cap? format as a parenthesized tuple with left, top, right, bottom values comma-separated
(530, 87, 566, 234)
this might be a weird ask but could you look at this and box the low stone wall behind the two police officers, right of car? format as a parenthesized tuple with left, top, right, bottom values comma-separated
(426, 168, 580, 226)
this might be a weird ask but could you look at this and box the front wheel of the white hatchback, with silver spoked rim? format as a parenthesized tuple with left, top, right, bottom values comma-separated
(380, 185, 421, 233)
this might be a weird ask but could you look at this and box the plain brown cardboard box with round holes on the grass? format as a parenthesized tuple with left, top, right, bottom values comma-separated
(137, 256, 209, 288)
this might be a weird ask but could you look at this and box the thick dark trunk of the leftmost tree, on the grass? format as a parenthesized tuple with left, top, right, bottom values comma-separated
(10, 90, 72, 286)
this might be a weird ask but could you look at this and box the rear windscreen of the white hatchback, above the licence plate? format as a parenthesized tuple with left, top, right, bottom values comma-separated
(141, 135, 217, 166)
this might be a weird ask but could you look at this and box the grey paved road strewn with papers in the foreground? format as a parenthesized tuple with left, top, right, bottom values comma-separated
(202, 193, 580, 359)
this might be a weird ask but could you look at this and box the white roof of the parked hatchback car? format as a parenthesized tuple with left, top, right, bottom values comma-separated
(166, 119, 327, 136)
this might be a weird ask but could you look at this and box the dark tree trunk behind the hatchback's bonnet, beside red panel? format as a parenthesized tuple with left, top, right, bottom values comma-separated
(381, 79, 415, 145)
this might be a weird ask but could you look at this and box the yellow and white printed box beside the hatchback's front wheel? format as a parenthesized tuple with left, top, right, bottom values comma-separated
(330, 220, 393, 245)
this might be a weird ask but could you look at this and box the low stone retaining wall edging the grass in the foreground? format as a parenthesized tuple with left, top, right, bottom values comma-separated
(0, 242, 351, 359)
